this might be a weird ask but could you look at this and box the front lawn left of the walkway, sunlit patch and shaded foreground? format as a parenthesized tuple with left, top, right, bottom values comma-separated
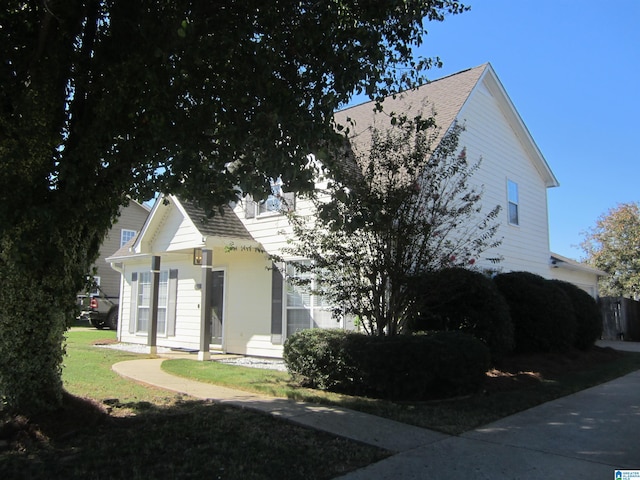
(0, 328, 388, 480)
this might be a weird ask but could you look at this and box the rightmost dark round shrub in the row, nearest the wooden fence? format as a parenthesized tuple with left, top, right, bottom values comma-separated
(551, 280, 602, 350)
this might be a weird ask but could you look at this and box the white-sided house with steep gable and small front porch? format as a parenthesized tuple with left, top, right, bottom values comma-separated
(107, 64, 599, 358)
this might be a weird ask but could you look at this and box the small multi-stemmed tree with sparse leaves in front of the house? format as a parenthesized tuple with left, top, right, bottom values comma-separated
(285, 117, 501, 335)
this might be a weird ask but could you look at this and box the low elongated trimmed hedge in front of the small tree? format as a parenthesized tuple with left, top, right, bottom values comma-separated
(283, 329, 489, 400)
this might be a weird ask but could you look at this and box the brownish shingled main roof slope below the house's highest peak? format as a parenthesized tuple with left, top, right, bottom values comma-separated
(335, 64, 488, 145)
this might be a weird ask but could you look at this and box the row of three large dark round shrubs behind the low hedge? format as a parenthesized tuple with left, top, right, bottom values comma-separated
(409, 268, 602, 360)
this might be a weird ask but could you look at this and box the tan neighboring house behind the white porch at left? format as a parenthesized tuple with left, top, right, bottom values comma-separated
(87, 200, 150, 299)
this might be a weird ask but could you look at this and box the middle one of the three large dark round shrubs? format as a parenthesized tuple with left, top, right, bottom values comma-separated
(494, 272, 576, 353)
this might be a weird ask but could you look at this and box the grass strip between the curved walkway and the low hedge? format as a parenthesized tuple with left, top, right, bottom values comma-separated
(162, 353, 640, 435)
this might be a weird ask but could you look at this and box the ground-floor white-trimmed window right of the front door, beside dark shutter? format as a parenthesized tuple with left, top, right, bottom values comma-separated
(285, 260, 338, 337)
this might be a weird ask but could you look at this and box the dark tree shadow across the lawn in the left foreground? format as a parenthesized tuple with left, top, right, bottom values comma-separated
(0, 394, 388, 480)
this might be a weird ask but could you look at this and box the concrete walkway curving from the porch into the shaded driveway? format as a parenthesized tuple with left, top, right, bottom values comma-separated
(113, 342, 640, 480)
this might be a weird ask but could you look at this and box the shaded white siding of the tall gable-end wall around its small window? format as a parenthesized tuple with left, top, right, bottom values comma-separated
(459, 82, 550, 277)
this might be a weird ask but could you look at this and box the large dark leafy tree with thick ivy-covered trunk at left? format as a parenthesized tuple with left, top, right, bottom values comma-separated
(0, 0, 466, 411)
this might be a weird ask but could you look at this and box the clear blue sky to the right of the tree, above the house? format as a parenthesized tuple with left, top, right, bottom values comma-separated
(382, 0, 640, 259)
